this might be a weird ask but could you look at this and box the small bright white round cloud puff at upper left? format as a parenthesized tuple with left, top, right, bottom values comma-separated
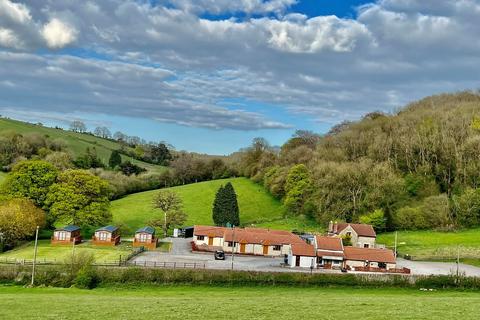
(42, 18, 78, 49)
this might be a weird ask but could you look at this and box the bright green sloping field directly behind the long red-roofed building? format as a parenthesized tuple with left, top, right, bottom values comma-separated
(112, 178, 315, 232)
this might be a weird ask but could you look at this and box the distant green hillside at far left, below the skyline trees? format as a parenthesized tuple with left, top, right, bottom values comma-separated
(0, 118, 165, 171)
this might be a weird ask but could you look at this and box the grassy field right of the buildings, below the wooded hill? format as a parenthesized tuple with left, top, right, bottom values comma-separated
(377, 229, 480, 264)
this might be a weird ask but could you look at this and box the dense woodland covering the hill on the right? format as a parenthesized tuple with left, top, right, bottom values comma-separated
(233, 92, 480, 230)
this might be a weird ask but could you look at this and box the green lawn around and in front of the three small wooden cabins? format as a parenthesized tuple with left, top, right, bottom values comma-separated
(0, 240, 132, 263)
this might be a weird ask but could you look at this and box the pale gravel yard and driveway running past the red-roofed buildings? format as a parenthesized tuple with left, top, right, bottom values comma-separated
(130, 238, 480, 277)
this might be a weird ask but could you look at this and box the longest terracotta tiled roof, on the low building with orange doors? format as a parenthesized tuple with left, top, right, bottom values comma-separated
(224, 228, 304, 245)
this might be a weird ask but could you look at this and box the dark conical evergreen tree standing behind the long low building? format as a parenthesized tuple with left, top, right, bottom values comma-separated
(212, 182, 240, 226)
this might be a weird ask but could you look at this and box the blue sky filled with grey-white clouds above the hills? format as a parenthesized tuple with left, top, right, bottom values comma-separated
(0, 0, 480, 154)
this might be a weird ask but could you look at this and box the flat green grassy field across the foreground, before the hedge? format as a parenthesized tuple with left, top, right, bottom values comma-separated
(0, 286, 480, 320)
